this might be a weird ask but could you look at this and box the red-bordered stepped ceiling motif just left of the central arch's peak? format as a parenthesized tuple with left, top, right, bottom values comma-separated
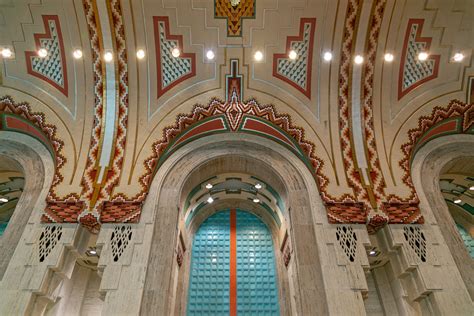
(153, 16, 196, 97)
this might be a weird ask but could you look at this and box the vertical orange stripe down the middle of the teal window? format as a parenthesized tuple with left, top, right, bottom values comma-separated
(229, 209, 237, 316)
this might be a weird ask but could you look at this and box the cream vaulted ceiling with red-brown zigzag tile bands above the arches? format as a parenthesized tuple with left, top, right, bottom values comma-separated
(0, 0, 474, 231)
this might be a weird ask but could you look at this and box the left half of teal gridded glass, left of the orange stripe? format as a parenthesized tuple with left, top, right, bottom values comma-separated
(187, 211, 230, 315)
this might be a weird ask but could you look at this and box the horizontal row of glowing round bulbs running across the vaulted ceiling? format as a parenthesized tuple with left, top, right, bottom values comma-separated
(1, 47, 465, 65)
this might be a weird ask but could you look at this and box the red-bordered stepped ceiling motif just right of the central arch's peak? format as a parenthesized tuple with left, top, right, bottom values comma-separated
(273, 18, 316, 98)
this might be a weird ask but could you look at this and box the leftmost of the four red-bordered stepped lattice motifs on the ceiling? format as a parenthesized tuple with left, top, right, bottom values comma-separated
(25, 15, 68, 97)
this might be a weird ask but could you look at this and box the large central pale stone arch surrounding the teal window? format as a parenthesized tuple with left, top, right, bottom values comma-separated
(141, 133, 327, 314)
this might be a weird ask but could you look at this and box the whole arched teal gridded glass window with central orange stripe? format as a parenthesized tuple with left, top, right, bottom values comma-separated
(187, 209, 279, 315)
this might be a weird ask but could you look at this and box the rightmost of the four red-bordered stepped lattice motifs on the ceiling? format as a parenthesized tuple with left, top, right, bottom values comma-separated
(398, 19, 440, 100)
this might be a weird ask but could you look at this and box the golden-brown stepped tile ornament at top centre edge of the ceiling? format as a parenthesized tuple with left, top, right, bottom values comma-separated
(214, 0, 255, 37)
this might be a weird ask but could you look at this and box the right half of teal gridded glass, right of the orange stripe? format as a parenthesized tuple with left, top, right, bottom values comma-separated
(237, 210, 280, 315)
